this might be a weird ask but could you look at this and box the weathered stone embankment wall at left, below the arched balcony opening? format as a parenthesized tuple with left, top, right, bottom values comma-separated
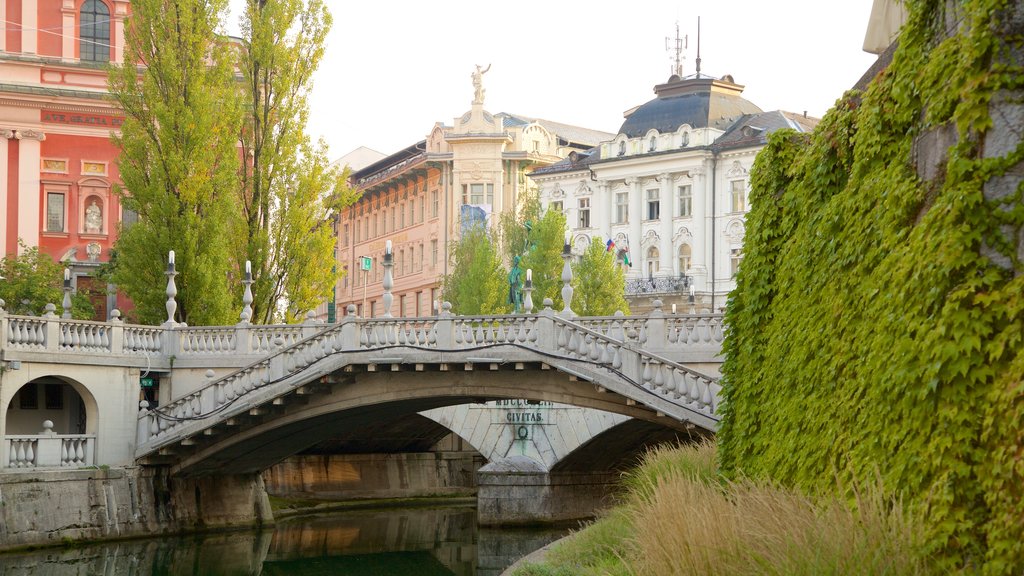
(0, 467, 273, 549)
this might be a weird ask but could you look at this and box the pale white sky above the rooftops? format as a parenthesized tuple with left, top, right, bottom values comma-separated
(227, 0, 876, 159)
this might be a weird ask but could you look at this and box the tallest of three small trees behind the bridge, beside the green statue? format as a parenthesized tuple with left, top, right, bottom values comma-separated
(501, 194, 565, 310)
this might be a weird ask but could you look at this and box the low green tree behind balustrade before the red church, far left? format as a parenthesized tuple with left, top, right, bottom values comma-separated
(0, 242, 94, 320)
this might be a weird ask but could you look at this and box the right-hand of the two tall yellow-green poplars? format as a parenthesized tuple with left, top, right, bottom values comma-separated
(239, 0, 355, 323)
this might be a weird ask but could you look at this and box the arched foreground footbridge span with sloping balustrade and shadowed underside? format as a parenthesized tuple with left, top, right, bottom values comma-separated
(136, 319, 718, 477)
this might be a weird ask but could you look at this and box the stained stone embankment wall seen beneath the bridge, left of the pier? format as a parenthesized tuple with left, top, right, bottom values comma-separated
(263, 451, 484, 500)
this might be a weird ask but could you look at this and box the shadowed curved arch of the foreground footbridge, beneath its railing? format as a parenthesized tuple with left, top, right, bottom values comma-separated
(147, 355, 687, 476)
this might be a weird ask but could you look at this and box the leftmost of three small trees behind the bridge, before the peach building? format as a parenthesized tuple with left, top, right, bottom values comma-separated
(441, 227, 512, 316)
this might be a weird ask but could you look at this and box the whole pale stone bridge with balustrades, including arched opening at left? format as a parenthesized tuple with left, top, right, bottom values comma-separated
(0, 297, 722, 475)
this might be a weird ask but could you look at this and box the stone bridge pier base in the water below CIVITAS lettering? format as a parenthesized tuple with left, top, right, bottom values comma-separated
(476, 456, 620, 526)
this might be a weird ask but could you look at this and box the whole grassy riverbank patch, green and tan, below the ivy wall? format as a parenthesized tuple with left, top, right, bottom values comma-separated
(513, 443, 939, 576)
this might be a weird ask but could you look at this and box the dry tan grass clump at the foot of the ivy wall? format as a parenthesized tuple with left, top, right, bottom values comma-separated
(628, 449, 933, 576)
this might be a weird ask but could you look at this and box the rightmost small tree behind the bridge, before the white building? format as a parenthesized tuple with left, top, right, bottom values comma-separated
(572, 236, 630, 316)
